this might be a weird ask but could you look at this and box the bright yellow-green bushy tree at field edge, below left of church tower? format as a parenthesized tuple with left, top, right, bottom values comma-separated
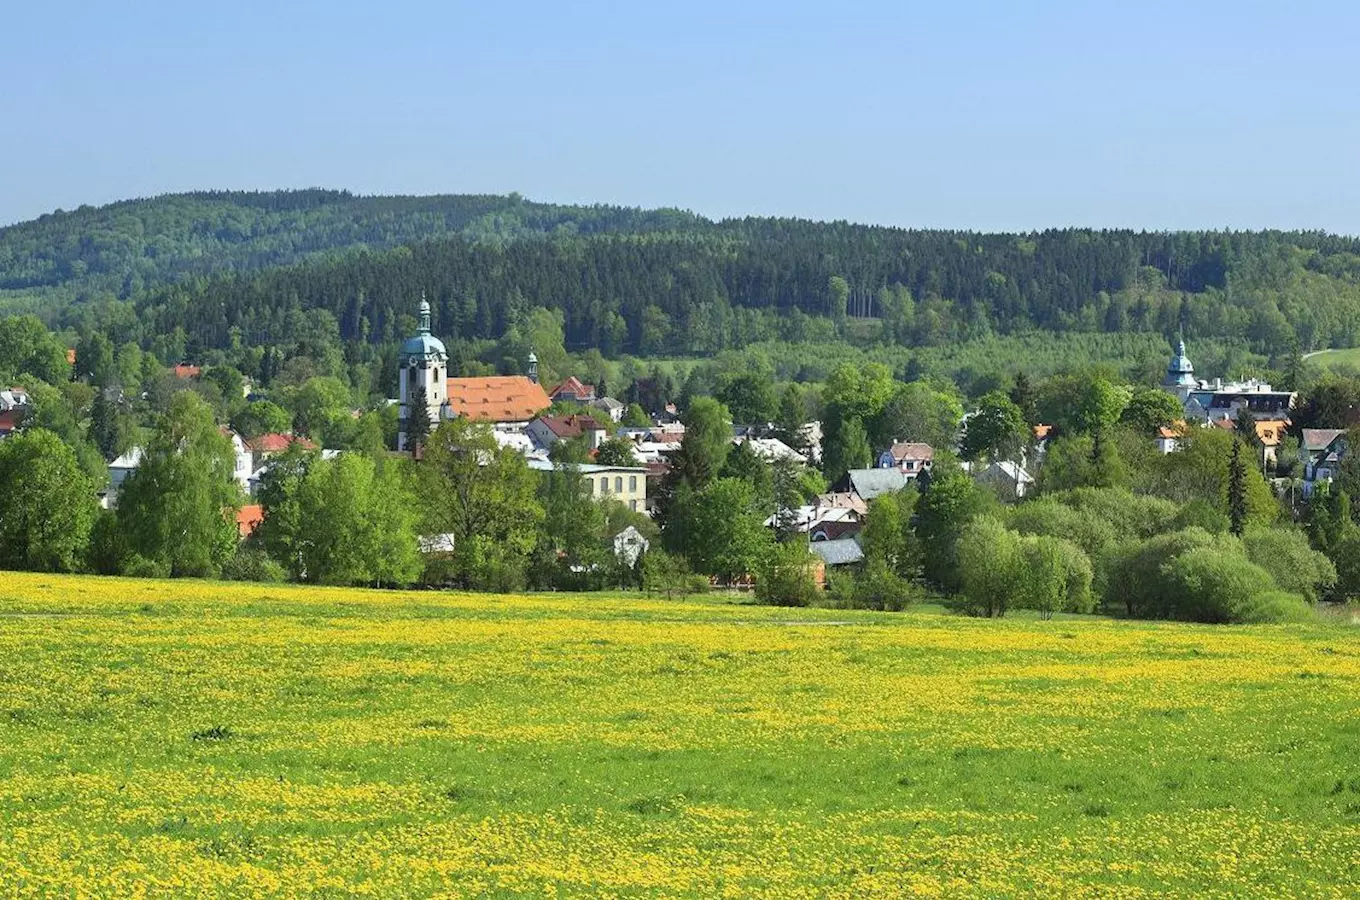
(296, 453, 420, 586)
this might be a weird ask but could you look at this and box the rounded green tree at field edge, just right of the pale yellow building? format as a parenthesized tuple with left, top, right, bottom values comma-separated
(679, 479, 774, 583)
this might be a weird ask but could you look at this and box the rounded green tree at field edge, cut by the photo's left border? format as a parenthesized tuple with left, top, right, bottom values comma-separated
(0, 428, 98, 572)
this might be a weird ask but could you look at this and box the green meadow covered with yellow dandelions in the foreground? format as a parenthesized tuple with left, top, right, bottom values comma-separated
(0, 572, 1360, 897)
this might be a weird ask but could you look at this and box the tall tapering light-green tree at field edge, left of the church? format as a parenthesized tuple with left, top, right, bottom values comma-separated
(117, 392, 241, 578)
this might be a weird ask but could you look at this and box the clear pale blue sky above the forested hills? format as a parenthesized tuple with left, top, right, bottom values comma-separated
(0, 0, 1360, 234)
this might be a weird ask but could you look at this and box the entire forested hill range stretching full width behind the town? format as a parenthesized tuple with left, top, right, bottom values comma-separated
(0, 190, 1360, 364)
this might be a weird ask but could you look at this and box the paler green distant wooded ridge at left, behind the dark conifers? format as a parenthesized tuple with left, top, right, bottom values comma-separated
(0, 189, 696, 299)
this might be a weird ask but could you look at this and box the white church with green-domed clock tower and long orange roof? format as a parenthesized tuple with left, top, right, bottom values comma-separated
(397, 295, 552, 450)
